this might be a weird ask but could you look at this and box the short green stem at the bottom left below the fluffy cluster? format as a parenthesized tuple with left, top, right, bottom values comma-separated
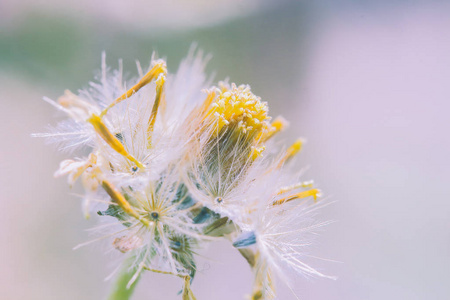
(107, 256, 140, 300)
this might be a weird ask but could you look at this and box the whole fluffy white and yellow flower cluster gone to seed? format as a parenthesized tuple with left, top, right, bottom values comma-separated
(37, 48, 326, 300)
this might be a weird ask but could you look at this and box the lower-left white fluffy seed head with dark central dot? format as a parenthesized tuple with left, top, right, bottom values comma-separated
(92, 169, 207, 285)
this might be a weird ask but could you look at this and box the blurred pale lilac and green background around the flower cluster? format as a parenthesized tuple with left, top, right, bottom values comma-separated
(0, 0, 450, 300)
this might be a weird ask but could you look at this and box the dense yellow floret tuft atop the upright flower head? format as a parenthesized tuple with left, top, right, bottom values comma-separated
(209, 83, 270, 133)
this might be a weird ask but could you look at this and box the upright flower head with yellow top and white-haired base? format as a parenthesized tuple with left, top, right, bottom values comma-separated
(185, 82, 270, 222)
